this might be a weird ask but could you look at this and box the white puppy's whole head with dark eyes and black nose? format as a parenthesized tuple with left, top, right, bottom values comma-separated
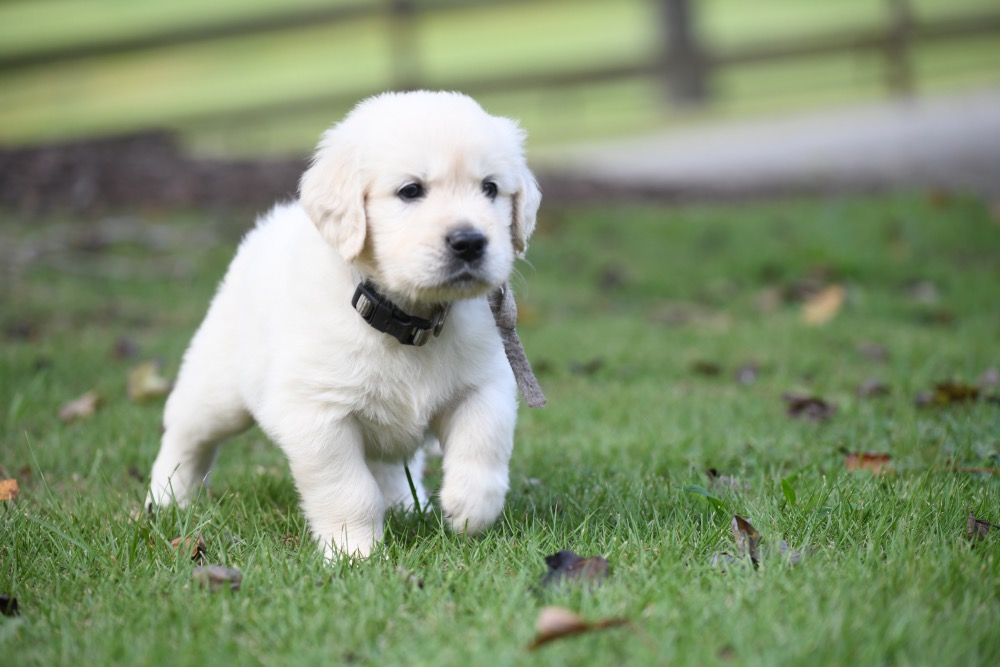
(300, 91, 541, 303)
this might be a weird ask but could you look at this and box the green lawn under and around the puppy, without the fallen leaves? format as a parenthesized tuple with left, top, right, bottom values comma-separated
(0, 195, 1000, 665)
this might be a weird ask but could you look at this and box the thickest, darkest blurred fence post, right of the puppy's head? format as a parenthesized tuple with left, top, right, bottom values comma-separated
(658, 0, 708, 106)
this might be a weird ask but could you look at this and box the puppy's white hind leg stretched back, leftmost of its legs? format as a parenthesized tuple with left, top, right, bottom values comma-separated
(146, 370, 253, 507)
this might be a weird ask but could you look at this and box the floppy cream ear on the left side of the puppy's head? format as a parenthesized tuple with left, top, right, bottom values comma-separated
(299, 127, 367, 262)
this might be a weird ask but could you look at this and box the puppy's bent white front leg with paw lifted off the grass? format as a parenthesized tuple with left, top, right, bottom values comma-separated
(437, 378, 517, 535)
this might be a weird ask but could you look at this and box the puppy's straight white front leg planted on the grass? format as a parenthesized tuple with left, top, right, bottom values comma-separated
(275, 414, 385, 559)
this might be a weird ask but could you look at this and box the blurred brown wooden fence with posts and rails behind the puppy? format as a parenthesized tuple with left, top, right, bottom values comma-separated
(0, 0, 1000, 126)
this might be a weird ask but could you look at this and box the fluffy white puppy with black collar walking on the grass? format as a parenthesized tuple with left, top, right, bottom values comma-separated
(147, 92, 541, 557)
